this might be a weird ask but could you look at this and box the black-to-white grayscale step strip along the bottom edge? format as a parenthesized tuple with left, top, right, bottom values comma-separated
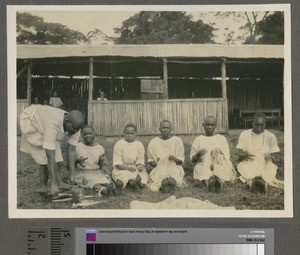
(86, 244, 265, 255)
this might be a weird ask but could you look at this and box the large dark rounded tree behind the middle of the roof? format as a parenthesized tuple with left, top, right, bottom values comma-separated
(114, 11, 214, 44)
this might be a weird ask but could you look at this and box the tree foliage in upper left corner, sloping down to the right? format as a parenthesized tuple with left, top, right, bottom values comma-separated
(17, 12, 89, 44)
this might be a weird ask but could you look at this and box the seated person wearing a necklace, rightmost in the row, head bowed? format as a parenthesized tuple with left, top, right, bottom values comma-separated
(236, 112, 283, 193)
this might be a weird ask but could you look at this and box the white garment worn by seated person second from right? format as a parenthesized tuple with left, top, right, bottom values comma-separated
(190, 134, 236, 181)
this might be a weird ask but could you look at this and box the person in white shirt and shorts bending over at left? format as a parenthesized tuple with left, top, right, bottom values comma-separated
(20, 105, 84, 194)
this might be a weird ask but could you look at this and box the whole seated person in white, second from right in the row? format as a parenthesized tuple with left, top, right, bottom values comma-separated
(190, 116, 236, 192)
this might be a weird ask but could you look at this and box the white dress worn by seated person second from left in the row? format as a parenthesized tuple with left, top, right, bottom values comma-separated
(112, 139, 148, 188)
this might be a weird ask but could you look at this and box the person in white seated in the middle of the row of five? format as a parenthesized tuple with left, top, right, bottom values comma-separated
(147, 120, 185, 193)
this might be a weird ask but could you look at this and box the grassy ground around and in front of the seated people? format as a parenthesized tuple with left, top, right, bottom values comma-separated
(17, 130, 284, 210)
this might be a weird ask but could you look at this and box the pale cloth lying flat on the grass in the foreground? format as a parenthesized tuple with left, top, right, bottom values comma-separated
(129, 196, 235, 210)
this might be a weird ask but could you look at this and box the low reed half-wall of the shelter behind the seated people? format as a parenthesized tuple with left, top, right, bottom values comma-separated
(88, 98, 228, 136)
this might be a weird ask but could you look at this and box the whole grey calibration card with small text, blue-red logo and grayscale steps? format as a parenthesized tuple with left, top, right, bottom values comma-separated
(75, 228, 274, 255)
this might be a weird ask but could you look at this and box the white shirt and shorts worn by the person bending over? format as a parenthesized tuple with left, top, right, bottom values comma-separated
(20, 105, 80, 165)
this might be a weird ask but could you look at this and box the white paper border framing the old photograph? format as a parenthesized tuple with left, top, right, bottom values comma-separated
(7, 4, 293, 218)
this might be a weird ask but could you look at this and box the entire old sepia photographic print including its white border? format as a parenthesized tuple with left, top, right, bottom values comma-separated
(7, 4, 293, 218)
